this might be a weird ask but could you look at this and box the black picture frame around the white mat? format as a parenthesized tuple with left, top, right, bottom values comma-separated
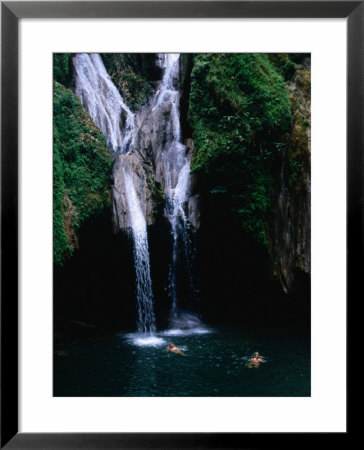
(1, 0, 356, 449)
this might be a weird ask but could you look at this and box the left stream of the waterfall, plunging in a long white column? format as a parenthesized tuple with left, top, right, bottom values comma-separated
(74, 53, 156, 333)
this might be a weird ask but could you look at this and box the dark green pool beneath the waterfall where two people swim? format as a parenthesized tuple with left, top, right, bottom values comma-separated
(54, 328, 310, 397)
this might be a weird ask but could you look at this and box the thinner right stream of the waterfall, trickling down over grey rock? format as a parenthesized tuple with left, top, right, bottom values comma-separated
(152, 53, 193, 323)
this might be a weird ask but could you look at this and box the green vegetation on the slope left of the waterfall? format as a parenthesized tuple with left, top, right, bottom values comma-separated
(53, 82, 111, 264)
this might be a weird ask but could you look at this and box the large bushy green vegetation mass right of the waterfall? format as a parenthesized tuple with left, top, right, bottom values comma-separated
(188, 54, 292, 243)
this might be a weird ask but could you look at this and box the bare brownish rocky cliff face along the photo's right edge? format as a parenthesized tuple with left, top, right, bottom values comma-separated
(266, 60, 311, 293)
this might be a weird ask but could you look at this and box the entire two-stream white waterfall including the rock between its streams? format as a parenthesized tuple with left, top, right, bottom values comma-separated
(74, 53, 198, 332)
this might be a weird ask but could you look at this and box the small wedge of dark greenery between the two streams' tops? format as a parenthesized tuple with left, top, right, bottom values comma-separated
(101, 53, 151, 111)
